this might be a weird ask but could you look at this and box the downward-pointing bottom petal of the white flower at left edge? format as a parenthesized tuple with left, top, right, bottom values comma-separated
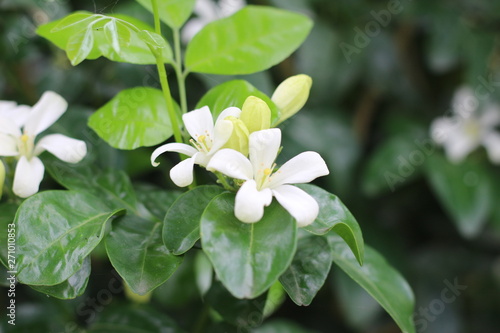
(12, 156, 45, 198)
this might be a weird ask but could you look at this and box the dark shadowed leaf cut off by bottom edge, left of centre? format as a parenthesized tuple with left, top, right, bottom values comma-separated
(88, 303, 184, 333)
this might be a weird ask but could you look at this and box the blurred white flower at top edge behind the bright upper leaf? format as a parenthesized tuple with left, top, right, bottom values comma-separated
(181, 0, 245, 44)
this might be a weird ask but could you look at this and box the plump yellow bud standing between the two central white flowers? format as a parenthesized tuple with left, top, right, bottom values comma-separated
(240, 96, 271, 133)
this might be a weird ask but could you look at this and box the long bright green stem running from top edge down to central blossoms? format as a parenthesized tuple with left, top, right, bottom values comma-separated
(151, 0, 183, 142)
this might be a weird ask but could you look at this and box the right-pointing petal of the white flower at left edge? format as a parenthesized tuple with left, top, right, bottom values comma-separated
(34, 134, 87, 163)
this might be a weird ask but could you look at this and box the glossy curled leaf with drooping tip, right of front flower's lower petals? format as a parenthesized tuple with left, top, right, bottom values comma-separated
(297, 184, 364, 265)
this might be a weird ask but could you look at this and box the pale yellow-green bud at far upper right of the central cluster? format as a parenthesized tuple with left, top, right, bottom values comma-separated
(271, 74, 312, 125)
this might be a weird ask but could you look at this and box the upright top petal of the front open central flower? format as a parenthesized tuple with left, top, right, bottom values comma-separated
(249, 128, 281, 175)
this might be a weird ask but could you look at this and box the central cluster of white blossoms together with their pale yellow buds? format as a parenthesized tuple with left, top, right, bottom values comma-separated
(151, 75, 329, 226)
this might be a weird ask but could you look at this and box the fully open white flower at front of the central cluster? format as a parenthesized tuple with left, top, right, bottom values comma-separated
(207, 128, 329, 227)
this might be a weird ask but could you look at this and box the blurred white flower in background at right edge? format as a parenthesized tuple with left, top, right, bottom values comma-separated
(431, 87, 500, 163)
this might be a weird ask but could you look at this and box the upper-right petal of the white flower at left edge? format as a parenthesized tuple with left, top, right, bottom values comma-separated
(24, 91, 68, 136)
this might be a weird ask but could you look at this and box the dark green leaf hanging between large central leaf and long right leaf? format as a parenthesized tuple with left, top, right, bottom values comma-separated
(280, 236, 332, 306)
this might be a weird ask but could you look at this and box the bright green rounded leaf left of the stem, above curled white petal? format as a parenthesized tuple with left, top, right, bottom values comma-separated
(89, 87, 173, 149)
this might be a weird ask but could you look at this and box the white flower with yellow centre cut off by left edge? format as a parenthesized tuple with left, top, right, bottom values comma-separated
(0, 91, 87, 198)
